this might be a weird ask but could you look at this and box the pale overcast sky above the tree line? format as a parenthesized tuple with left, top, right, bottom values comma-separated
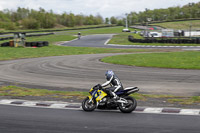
(0, 0, 200, 18)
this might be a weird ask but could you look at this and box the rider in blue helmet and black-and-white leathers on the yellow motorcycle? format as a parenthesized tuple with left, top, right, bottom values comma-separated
(101, 70, 123, 99)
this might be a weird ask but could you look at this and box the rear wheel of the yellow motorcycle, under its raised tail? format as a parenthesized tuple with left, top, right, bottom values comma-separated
(119, 96, 137, 113)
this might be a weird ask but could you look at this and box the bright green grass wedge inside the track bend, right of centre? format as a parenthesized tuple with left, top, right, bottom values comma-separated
(102, 51, 200, 69)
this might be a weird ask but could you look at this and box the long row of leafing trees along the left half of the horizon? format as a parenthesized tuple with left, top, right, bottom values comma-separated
(0, 7, 104, 30)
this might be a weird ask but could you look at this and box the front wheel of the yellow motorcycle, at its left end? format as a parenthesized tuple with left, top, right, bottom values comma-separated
(82, 97, 96, 112)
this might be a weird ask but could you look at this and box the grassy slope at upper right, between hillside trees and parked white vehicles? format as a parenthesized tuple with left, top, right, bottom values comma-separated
(152, 20, 200, 30)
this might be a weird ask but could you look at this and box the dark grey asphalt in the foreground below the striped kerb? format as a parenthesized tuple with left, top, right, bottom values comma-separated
(0, 105, 200, 133)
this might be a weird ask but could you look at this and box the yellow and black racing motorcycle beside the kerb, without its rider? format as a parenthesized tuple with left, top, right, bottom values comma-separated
(82, 84, 139, 113)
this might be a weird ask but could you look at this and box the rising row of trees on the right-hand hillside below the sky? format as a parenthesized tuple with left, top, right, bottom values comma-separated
(128, 2, 200, 25)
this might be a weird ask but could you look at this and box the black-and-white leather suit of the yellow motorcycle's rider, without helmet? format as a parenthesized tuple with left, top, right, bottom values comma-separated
(101, 75, 123, 96)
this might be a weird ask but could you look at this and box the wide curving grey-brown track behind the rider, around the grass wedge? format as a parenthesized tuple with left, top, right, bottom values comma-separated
(0, 54, 200, 95)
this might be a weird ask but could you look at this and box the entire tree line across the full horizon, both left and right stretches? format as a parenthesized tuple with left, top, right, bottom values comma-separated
(0, 2, 200, 30)
